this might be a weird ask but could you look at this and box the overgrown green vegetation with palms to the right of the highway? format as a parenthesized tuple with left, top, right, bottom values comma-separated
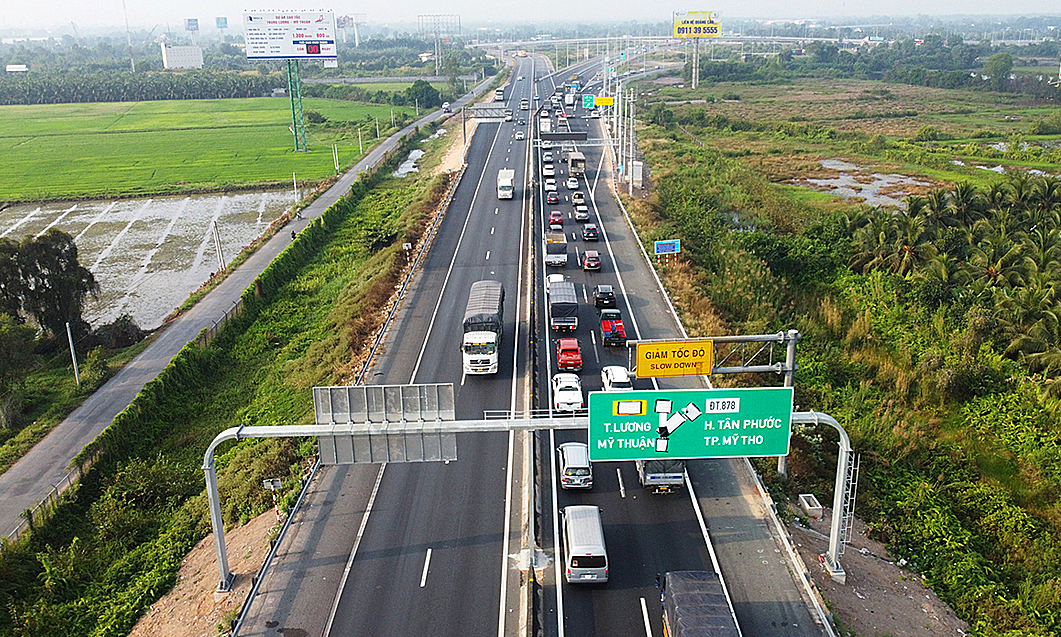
(629, 75, 1061, 636)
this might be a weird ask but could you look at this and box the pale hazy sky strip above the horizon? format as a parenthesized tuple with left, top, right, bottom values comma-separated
(0, 0, 1061, 33)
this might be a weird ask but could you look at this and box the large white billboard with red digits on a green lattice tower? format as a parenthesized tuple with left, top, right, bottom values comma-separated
(243, 11, 337, 59)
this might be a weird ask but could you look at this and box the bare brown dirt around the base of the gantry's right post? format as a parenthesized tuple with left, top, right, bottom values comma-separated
(788, 510, 969, 637)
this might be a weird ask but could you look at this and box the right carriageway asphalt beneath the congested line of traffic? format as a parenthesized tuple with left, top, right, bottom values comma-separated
(535, 61, 822, 637)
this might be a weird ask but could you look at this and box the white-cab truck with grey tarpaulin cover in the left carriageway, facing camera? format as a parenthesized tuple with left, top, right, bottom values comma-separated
(460, 280, 505, 374)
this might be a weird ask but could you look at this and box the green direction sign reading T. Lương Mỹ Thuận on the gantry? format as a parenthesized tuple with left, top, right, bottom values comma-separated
(589, 388, 793, 462)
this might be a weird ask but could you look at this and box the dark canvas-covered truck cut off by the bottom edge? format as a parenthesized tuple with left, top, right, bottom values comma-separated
(660, 571, 742, 637)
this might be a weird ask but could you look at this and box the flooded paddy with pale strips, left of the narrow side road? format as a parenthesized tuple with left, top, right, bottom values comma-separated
(0, 191, 294, 329)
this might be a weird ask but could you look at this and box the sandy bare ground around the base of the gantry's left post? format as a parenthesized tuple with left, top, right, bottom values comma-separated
(129, 511, 276, 637)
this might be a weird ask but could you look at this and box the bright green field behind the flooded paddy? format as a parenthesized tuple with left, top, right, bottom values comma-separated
(0, 98, 413, 202)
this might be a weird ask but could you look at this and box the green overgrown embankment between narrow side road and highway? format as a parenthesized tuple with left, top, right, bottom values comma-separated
(0, 125, 449, 637)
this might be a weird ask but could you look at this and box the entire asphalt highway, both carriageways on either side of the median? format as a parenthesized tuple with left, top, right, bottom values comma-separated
(240, 57, 822, 637)
